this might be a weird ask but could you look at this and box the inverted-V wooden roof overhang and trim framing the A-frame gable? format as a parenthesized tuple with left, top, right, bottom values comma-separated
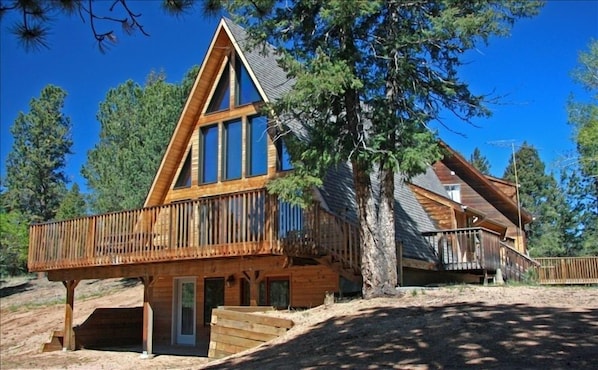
(144, 18, 269, 207)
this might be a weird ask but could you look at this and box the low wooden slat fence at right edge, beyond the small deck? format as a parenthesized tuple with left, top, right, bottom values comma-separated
(536, 256, 598, 284)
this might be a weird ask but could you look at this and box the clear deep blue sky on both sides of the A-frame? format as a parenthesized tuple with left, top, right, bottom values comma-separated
(0, 0, 598, 188)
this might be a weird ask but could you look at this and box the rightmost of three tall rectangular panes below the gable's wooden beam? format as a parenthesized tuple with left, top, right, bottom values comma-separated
(247, 116, 268, 176)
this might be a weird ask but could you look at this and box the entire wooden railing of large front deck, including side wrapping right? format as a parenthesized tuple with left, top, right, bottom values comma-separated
(29, 189, 359, 271)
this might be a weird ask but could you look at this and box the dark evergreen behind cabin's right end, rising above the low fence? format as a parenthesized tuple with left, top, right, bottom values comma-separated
(503, 142, 567, 256)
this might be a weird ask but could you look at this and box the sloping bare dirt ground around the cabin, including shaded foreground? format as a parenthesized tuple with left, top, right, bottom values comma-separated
(0, 280, 598, 370)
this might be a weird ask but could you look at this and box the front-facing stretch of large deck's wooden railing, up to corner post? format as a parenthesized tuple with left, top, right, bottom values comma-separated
(28, 189, 279, 271)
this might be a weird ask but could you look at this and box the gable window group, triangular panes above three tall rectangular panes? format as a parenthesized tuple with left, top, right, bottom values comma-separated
(199, 51, 270, 184)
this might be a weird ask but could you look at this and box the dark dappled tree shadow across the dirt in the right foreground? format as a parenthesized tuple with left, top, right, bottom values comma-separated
(207, 303, 598, 369)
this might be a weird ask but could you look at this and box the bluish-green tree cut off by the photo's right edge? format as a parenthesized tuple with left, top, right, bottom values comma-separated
(567, 40, 598, 255)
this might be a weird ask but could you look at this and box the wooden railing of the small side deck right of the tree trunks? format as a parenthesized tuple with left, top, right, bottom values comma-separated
(423, 228, 537, 280)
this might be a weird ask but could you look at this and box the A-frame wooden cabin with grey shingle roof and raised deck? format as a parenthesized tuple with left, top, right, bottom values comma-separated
(29, 19, 540, 355)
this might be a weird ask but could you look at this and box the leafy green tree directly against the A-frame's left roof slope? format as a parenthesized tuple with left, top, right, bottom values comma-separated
(82, 71, 194, 213)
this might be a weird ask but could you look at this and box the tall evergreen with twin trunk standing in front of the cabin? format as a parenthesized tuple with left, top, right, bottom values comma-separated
(211, 0, 538, 298)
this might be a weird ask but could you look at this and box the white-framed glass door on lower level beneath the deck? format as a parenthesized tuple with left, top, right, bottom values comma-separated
(174, 278, 196, 345)
